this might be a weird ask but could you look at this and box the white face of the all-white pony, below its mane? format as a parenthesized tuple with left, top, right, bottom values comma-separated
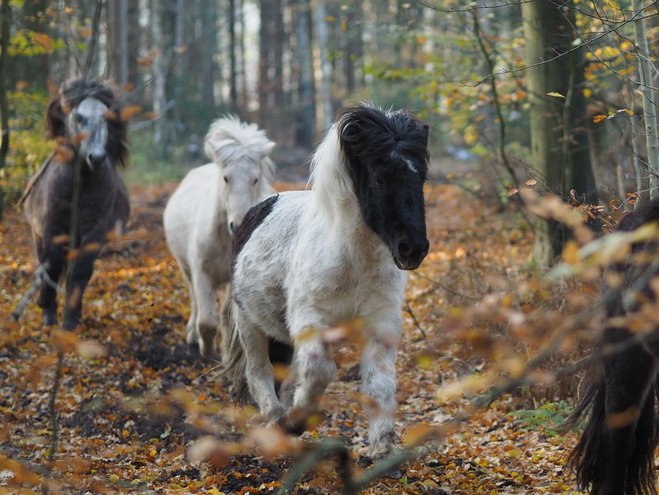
(221, 163, 261, 234)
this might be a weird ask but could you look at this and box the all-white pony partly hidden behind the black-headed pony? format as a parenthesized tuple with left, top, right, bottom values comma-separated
(164, 116, 275, 357)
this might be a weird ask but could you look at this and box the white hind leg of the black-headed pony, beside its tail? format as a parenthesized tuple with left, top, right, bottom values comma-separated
(240, 307, 286, 424)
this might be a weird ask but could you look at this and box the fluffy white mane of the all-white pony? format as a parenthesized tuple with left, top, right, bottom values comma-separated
(204, 115, 275, 194)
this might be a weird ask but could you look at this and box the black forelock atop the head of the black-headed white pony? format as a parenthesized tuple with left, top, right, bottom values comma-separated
(338, 105, 429, 171)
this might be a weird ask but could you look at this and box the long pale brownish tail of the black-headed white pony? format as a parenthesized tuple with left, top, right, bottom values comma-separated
(220, 286, 251, 405)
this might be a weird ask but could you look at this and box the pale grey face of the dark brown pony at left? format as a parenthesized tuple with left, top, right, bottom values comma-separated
(70, 98, 108, 168)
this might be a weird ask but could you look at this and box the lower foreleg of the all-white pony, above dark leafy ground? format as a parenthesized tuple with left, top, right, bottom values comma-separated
(192, 269, 220, 358)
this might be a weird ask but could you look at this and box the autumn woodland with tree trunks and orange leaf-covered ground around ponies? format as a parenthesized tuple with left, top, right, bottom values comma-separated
(0, 0, 659, 494)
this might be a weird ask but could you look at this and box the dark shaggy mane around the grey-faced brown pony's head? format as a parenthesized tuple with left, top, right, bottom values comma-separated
(46, 78, 129, 168)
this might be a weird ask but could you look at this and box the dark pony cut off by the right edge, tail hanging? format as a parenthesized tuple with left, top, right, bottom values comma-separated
(568, 198, 659, 495)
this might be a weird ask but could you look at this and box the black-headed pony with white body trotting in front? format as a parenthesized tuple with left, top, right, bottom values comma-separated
(225, 105, 428, 458)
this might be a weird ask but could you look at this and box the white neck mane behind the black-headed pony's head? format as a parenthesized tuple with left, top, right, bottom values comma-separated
(309, 123, 357, 218)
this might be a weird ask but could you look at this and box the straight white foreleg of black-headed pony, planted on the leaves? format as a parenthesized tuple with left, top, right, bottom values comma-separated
(361, 340, 396, 459)
